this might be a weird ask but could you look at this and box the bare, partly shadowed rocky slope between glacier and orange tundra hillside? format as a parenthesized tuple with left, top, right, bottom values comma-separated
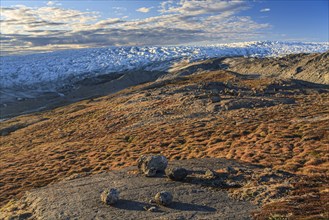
(0, 52, 329, 118)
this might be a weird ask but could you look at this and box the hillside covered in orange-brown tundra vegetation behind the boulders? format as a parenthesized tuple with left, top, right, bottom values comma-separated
(0, 54, 329, 217)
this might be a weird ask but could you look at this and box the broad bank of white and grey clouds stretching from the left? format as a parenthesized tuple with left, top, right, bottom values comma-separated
(0, 0, 270, 55)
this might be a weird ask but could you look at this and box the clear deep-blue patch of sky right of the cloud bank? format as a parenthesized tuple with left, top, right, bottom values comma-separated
(243, 0, 329, 42)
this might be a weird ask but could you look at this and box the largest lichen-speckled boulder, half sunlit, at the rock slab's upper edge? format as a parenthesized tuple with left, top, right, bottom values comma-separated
(137, 155, 168, 177)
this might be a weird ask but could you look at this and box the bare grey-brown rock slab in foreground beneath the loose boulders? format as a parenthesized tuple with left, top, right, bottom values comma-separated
(2, 159, 257, 219)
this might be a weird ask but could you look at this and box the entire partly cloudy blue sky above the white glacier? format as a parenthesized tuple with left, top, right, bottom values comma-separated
(0, 0, 329, 55)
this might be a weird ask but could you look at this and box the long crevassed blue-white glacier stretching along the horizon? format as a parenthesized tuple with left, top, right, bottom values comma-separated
(0, 41, 329, 91)
